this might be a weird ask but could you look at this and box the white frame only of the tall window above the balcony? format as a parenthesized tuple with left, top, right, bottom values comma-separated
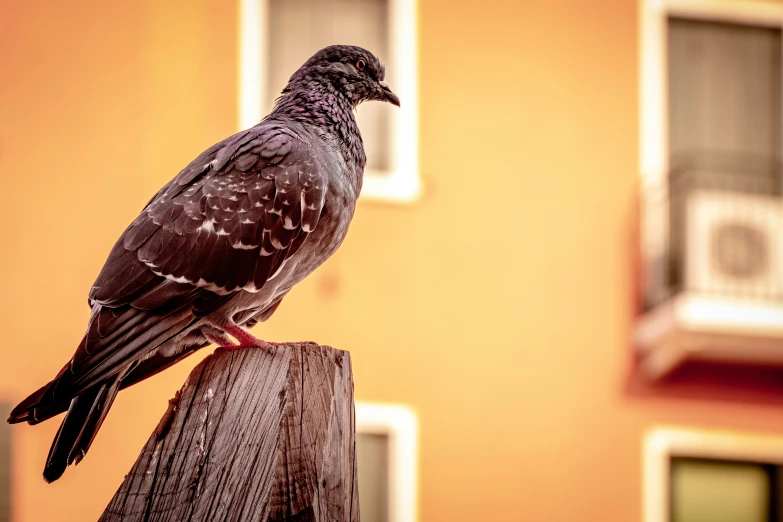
(639, 0, 783, 188)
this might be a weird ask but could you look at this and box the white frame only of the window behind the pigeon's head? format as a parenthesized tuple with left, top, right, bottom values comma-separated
(237, 0, 422, 203)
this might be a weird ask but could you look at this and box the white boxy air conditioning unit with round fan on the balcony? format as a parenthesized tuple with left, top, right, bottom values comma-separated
(683, 190, 783, 300)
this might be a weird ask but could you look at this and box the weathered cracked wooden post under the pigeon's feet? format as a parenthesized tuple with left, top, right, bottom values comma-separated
(100, 343, 359, 522)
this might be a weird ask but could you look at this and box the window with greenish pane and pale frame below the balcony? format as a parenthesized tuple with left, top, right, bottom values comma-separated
(643, 428, 783, 522)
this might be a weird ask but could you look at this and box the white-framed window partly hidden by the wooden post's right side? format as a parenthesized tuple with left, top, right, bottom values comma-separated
(356, 402, 417, 522)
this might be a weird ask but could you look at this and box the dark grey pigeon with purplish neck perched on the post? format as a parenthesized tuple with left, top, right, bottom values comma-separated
(8, 45, 400, 483)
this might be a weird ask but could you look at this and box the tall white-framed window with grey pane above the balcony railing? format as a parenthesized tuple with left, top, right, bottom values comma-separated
(640, 0, 783, 185)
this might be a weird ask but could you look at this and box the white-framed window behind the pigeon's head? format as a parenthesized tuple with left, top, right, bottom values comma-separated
(239, 0, 420, 202)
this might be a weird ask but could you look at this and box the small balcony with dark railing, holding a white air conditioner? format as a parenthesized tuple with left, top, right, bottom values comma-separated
(634, 152, 783, 379)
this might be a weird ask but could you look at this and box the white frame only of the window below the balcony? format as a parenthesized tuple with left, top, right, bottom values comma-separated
(642, 427, 783, 522)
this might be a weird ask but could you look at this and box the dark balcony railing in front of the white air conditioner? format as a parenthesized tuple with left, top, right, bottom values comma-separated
(644, 152, 783, 309)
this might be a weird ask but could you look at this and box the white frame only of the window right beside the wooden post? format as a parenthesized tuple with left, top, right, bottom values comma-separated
(356, 402, 418, 522)
